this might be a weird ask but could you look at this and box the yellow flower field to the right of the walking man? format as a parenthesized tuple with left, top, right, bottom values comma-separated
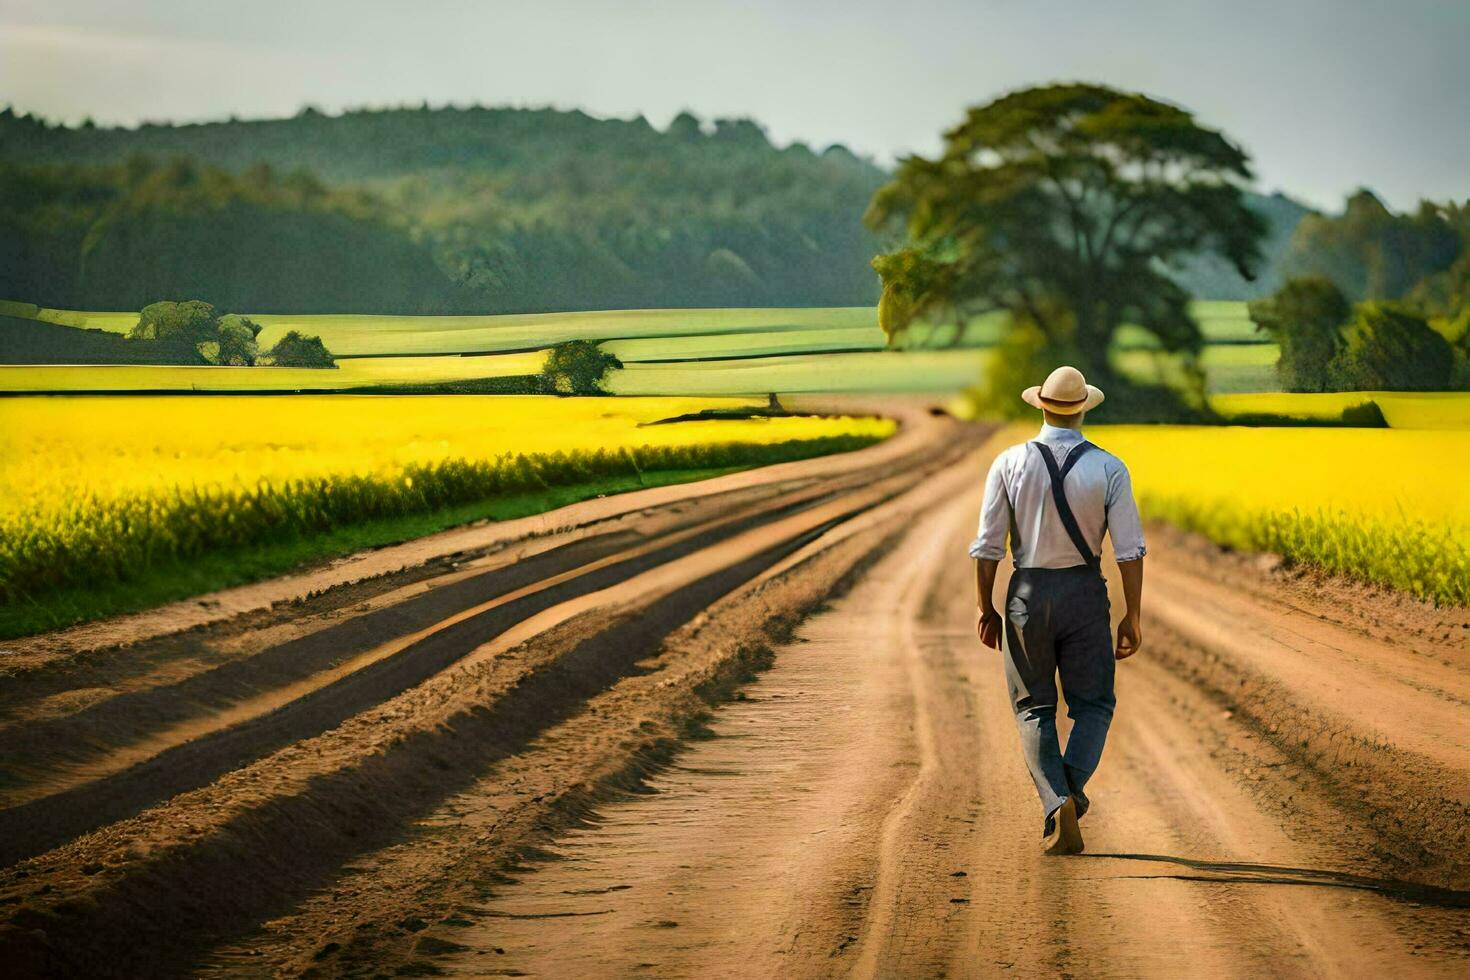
(1088, 426, 1470, 605)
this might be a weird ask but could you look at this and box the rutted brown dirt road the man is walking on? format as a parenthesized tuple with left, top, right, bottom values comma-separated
(0, 414, 1470, 977)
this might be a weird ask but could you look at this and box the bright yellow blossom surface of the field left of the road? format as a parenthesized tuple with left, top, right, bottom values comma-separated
(0, 395, 894, 513)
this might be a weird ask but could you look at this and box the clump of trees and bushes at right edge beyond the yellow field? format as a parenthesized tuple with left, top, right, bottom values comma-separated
(1250, 191, 1470, 391)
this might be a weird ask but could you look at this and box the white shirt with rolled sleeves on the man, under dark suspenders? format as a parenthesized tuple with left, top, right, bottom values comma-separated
(970, 423, 1148, 569)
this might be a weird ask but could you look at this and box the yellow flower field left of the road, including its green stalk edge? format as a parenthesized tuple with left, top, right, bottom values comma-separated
(0, 395, 894, 605)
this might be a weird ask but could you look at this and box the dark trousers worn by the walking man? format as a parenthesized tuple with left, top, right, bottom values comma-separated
(1005, 566, 1116, 817)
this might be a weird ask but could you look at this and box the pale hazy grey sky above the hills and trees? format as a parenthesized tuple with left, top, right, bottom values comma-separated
(0, 0, 1470, 207)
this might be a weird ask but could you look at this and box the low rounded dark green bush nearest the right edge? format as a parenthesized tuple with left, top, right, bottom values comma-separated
(1330, 303, 1455, 391)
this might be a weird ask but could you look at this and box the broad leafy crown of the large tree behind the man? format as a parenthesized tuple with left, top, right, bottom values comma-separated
(867, 84, 1266, 390)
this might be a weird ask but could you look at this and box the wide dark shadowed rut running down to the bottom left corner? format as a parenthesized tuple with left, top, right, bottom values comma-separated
(0, 514, 850, 976)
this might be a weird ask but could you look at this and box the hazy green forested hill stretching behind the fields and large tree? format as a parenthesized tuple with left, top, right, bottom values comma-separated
(0, 107, 1301, 313)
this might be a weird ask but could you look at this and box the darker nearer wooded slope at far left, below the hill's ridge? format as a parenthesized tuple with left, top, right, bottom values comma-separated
(0, 160, 453, 313)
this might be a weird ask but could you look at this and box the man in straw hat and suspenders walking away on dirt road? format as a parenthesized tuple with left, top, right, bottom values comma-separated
(970, 367, 1145, 854)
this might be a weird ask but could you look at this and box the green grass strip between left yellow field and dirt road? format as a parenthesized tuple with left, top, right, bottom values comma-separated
(0, 463, 740, 643)
